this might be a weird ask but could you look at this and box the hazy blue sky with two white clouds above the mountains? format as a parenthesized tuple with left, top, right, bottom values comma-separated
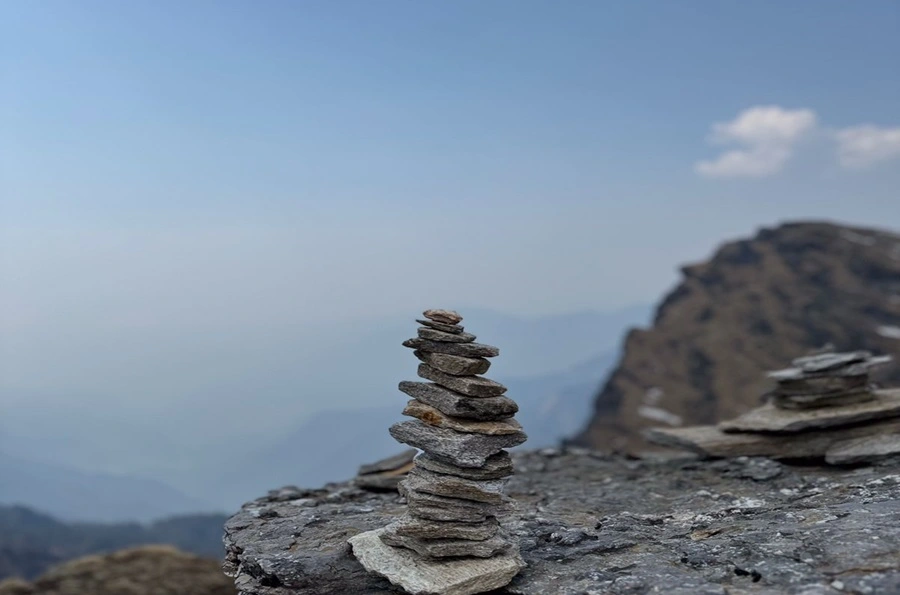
(0, 0, 900, 492)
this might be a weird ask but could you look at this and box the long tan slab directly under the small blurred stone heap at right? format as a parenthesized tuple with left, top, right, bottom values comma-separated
(719, 390, 900, 434)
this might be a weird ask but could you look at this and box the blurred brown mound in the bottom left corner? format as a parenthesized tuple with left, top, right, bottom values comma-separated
(0, 546, 235, 595)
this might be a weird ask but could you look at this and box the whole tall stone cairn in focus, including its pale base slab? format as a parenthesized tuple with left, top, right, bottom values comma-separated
(350, 310, 527, 595)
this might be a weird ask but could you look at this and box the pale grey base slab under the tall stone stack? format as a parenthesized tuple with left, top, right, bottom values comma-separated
(348, 529, 525, 595)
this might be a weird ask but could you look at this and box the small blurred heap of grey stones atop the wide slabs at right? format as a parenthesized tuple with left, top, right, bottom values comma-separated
(768, 351, 891, 409)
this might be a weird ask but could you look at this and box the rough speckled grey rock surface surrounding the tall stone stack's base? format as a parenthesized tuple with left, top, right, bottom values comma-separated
(224, 449, 900, 595)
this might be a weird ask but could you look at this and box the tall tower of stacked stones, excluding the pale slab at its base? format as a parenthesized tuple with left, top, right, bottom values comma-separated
(380, 310, 526, 560)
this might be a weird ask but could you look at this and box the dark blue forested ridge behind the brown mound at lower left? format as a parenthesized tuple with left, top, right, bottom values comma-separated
(0, 506, 227, 580)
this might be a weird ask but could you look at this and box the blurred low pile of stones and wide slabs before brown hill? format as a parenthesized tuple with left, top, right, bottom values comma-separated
(648, 351, 900, 465)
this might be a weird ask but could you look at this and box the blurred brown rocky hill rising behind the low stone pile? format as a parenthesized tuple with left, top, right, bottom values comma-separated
(572, 223, 900, 450)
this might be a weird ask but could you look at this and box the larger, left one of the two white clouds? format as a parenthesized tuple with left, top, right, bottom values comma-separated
(694, 105, 816, 178)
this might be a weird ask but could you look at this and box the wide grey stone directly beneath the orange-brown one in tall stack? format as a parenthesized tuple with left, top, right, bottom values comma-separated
(389, 420, 527, 467)
